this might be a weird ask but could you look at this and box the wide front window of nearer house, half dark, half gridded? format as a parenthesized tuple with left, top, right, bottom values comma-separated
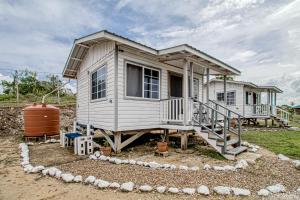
(126, 63, 159, 99)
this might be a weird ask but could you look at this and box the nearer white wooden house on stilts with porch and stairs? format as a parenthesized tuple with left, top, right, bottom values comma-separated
(63, 30, 246, 159)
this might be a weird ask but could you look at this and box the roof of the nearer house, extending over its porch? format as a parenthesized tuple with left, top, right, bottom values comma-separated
(63, 30, 241, 78)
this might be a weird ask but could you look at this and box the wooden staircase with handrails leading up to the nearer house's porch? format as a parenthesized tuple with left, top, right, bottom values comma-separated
(193, 100, 247, 160)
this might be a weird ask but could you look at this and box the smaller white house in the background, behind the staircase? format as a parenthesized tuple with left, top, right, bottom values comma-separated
(205, 79, 289, 125)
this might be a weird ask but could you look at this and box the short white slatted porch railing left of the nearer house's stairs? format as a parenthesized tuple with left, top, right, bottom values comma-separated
(160, 98, 193, 123)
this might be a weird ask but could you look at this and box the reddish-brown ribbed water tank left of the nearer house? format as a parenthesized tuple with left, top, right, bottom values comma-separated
(24, 104, 60, 137)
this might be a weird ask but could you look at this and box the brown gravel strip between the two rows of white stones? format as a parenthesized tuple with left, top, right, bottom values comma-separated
(59, 152, 300, 192)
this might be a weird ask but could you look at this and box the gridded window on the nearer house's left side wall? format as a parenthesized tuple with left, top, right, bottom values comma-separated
(92, 66, 107, 100)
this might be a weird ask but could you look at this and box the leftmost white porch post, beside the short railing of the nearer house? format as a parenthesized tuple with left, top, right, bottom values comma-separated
(183, 60, 189, 125)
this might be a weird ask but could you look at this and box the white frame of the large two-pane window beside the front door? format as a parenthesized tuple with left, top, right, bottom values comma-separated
(124, 60, 161, 101)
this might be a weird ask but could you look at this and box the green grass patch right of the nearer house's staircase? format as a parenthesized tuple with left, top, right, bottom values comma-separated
(242, 131, 300, 159)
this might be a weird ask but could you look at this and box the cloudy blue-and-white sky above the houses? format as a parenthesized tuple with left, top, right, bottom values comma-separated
(0, 0, 300, 104)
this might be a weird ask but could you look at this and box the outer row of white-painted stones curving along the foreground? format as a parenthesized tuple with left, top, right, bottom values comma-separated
(19, 143, 300, 196)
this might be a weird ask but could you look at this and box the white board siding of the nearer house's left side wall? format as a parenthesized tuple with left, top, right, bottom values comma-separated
(76, 42, 114, 130)
